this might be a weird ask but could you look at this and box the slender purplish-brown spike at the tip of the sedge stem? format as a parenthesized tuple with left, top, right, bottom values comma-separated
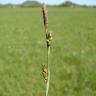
(42, 4, 48, 29)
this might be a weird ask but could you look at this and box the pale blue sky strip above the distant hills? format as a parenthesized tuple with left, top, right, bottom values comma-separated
(0, 0, 96, 5)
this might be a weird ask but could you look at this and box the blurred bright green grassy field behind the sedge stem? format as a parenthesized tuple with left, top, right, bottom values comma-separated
(0, 8, 96, 96)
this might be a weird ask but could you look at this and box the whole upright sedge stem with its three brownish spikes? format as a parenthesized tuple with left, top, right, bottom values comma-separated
(42, 4, 52, 96)
